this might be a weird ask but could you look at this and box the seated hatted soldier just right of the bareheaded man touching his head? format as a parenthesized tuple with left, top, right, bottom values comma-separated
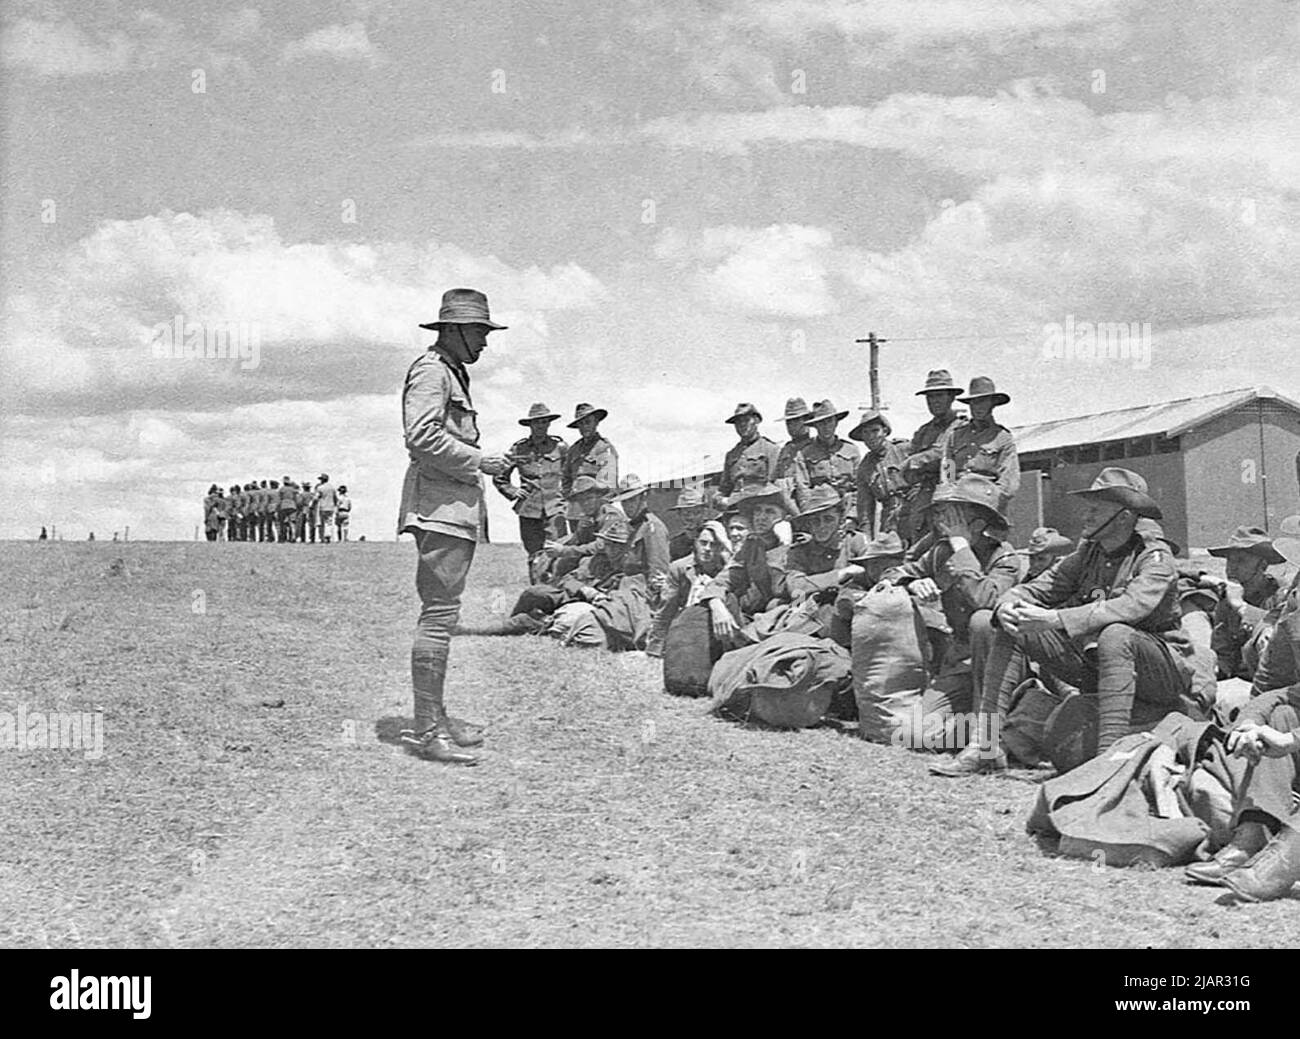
(699, 484, 790, 641)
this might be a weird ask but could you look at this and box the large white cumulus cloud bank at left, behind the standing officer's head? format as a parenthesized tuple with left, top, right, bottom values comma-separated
(0, 209, 606, 411)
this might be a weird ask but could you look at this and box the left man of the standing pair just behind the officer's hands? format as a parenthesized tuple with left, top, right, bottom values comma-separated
(493, 403, 568, 584)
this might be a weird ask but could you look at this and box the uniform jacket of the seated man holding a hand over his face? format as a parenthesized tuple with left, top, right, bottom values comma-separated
(881, 534, 1021, 644)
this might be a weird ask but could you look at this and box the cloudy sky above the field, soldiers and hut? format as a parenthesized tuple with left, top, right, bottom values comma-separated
(0, 0, 1300, 540)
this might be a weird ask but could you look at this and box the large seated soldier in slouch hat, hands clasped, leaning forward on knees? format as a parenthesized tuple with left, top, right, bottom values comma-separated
(931, 468, 1201, 776)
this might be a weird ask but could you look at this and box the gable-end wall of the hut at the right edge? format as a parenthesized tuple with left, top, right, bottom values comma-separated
(1183, 401, 1300, 547)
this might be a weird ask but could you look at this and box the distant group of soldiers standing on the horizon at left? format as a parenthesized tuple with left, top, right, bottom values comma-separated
(203, 473, 352, 544)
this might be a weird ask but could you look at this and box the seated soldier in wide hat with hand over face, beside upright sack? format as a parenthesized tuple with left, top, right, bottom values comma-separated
(881, 473, 1021, 749)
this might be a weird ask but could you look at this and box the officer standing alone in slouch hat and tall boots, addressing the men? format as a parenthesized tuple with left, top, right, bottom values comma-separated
(397, 289, 507, 765)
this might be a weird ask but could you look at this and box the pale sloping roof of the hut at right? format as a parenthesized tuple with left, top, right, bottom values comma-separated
(1011, 386, 1300, 455)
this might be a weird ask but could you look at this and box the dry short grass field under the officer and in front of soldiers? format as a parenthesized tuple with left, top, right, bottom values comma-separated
(0, 542, 1300, 951)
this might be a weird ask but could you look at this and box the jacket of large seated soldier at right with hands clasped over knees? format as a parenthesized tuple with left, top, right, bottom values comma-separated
(1000, 534, 1190, 650)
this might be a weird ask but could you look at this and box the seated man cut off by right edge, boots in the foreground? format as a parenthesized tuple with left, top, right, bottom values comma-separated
(1186, 607, 1300, 901)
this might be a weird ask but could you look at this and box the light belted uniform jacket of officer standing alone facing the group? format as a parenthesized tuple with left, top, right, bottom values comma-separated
(398, 347, 484, 541)
